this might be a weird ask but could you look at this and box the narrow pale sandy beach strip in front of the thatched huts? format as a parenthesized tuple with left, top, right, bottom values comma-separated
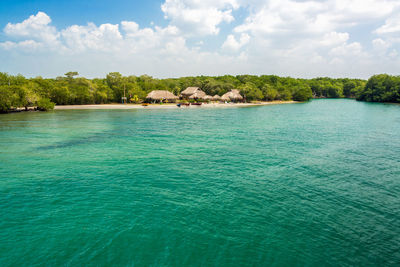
(54, 101, 299, 110)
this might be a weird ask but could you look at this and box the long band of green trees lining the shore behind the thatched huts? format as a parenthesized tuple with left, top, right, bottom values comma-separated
(0, 72, 400, 112)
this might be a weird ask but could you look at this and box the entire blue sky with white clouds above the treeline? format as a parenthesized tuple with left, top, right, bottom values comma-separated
(0, 0, 400, 78)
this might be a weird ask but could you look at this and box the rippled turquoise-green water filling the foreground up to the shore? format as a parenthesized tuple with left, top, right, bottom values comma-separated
(0, 100, 400, 266)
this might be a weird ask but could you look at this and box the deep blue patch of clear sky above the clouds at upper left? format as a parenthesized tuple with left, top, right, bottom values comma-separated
(0, 0, 166, 28)
